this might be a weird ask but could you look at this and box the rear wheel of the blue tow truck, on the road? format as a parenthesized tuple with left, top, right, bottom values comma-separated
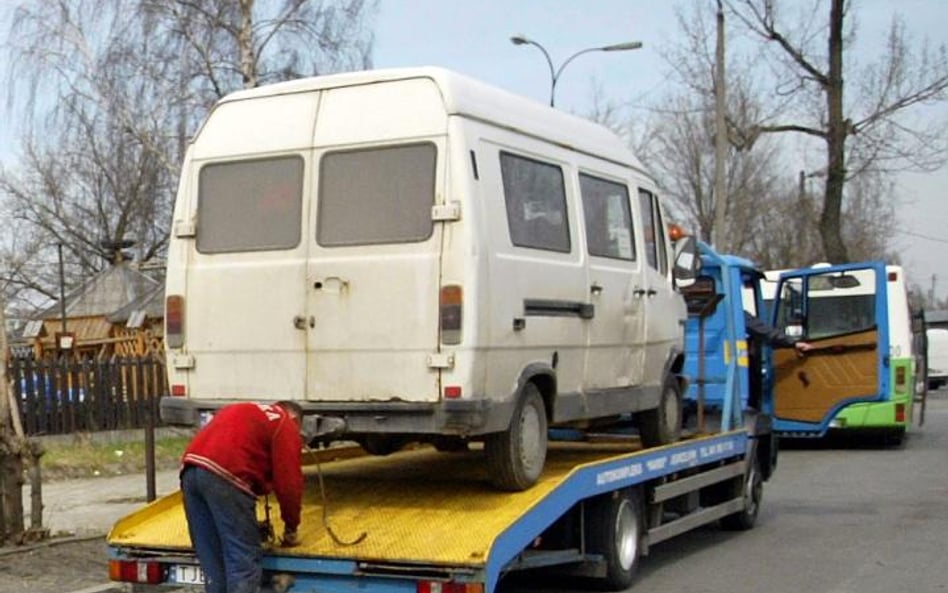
(588, 490, 642, 591)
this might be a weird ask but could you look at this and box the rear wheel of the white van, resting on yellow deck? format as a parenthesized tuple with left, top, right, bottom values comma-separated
(484, 383, 547, 492)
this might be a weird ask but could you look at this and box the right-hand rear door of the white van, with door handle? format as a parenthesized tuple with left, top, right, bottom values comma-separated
(306, 79, 452, 403)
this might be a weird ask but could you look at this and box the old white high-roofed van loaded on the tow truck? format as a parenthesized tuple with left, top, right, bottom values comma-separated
(161, 68, 696, 489)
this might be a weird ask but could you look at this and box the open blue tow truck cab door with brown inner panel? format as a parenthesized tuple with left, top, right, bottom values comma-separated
(772, 262, 889, 436)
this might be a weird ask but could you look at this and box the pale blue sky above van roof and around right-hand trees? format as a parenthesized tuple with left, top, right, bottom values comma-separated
(375, 0, 948, 298)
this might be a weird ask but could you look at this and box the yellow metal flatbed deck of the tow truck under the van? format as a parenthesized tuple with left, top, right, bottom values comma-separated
(108, 443, 638, 566)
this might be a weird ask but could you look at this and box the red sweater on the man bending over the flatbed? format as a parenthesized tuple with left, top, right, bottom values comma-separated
(181, 403, 303, 531)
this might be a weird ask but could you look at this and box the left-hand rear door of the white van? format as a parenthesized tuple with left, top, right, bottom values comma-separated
(167, 93, 317, 400)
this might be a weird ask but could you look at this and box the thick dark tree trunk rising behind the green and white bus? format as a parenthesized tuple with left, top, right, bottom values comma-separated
(820, 0, 849, 264)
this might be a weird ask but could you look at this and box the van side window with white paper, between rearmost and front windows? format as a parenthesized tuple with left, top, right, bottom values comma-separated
(579, 173, 635, 261)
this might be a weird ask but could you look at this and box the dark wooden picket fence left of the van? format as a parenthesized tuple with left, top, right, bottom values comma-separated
(7, 357, 168, 436)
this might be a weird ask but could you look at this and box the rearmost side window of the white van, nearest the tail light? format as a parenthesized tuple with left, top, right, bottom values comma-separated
(500, 153, 571, 253)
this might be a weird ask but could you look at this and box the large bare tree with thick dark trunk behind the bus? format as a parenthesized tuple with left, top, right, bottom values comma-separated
(727, 0, 948, 263)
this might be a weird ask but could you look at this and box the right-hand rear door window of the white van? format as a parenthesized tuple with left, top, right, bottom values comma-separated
(316, 143, 437, 247)
